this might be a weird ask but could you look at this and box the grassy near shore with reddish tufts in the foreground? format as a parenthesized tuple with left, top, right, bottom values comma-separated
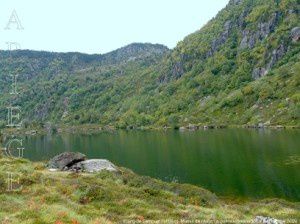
(0, 158, 300, 223)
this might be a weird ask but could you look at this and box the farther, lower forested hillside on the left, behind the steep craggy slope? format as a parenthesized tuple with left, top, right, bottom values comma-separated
(0, 43, 169, 126)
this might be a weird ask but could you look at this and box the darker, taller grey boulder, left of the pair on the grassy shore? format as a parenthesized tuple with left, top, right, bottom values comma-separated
(47, 152, 86, 170)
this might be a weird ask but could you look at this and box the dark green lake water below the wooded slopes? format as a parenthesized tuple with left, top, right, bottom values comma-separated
(19, 129, 300, 201)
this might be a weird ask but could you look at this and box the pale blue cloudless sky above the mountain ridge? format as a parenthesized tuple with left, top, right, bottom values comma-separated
(0, 0, 229, 54)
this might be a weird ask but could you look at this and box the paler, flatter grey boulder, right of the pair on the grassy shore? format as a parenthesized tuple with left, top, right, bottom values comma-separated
(70, 159, 118, 173)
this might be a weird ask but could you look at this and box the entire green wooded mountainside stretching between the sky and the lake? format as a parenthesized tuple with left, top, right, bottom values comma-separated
(0, 0, 300, 128)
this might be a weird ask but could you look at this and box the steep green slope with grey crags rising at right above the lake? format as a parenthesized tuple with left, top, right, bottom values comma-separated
(152, 0, 300, 125)
